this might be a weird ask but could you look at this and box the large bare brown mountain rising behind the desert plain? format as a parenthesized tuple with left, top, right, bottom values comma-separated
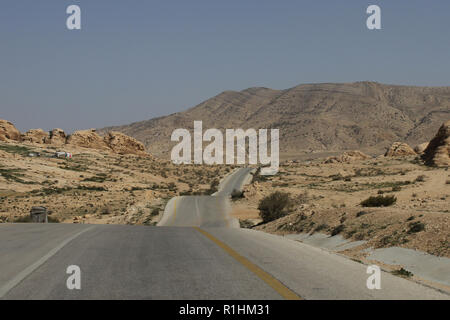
(99, 82, 450, 158)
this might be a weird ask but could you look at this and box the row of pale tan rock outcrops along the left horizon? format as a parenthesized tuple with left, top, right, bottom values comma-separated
(0, 119, 147, 155)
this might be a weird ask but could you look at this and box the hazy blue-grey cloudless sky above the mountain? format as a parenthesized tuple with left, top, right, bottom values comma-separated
(0, 0, 450, 132)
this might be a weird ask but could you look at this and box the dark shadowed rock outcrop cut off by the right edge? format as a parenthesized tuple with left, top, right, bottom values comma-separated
(422, 120, 450, 167)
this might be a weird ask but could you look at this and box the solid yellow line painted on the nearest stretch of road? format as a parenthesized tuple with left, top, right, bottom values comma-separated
(194, 227, 303, 300)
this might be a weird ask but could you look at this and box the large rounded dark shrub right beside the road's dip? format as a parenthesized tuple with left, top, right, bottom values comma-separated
(258, 191, 292, 222)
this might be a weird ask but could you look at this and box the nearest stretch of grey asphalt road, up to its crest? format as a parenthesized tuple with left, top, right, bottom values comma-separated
(0, 224, 449, 300)
